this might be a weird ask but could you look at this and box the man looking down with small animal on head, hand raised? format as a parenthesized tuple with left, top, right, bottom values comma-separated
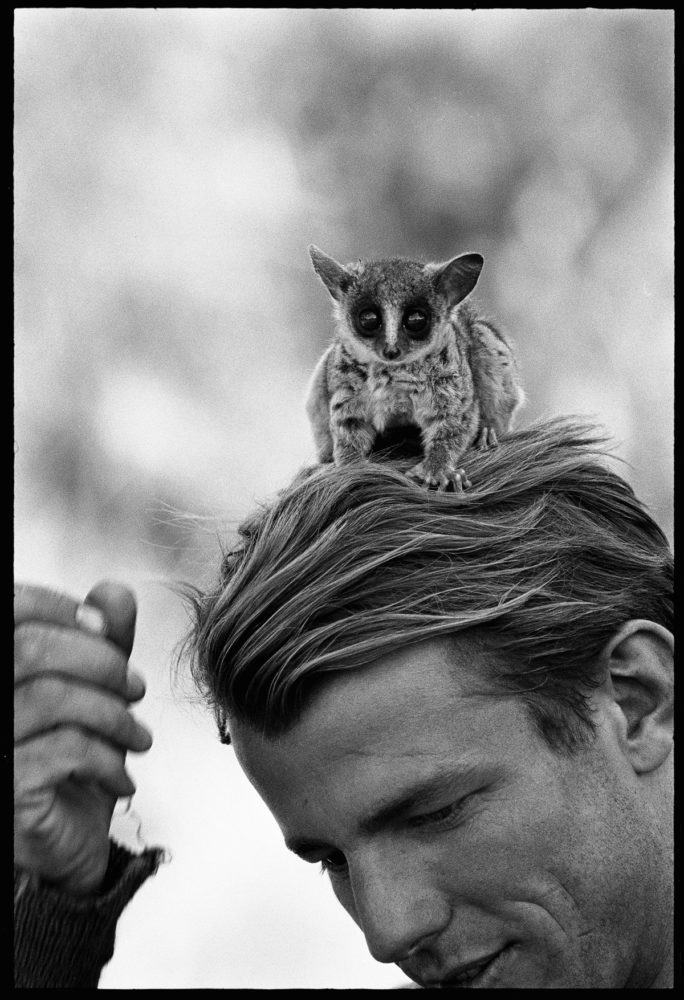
(15, 420, 673, 989)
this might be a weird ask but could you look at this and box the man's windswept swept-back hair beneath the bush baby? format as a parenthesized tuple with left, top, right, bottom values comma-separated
(185, 418, 673, 752)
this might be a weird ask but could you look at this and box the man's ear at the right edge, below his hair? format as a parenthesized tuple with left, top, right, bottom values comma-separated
(605, 618, 674, 774)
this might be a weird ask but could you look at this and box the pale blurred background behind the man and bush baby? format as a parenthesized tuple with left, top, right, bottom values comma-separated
(15, 8, 673, 989)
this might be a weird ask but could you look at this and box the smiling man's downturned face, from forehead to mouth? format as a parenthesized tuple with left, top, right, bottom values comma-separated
(231, 640, 667, 989)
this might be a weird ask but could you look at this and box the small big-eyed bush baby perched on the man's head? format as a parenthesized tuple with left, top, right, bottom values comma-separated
(306, 246, 524, 490)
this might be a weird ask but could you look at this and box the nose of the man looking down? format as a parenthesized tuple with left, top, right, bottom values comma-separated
(352, 864, 450, 962)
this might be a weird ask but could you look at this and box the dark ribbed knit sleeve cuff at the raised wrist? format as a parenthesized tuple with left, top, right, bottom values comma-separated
(14, 841, 164, 989)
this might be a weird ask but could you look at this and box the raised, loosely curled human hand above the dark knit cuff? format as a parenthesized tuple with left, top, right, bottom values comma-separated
(14, 582, 152, 895)
